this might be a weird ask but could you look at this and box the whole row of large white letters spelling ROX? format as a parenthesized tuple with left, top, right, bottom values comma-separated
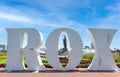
(5, 28, 120, 71)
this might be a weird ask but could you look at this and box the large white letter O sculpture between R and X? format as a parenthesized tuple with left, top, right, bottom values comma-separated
(46, 28, 83, 71)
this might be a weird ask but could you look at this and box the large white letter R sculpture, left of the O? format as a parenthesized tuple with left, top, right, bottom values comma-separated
(5, 28, 45, 71)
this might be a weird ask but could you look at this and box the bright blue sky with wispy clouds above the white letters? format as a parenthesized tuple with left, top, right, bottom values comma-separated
(0, 0, 120, 49)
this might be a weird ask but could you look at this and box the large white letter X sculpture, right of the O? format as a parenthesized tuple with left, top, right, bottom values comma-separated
(87, 29, 118, 71)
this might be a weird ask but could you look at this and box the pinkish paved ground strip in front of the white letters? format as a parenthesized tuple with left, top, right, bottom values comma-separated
(0, 68, 120, 77)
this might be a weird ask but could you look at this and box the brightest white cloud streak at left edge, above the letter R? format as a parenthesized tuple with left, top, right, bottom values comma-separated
(0, 13, 31, 23)
